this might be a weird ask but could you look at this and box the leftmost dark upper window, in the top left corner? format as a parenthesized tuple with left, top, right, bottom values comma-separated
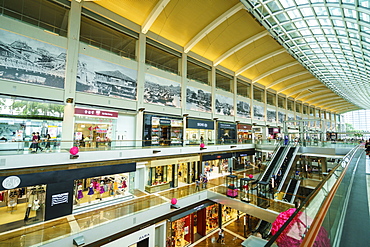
(0, 0, 69, 37)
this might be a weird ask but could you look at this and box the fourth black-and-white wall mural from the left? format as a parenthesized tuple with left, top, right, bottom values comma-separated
(186, 86, 212, 112)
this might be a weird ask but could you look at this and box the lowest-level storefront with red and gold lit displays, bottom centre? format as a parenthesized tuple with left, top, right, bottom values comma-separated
(169, 202, 219, 247)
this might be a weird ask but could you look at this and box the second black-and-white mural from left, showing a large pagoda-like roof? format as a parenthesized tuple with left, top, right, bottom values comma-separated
(76, 54, 137, 100)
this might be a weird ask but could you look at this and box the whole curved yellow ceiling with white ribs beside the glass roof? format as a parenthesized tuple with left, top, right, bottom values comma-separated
(90, 0, 364, 113)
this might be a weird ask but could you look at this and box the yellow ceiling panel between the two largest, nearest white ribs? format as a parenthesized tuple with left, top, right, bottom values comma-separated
(150, 0, 239, 46)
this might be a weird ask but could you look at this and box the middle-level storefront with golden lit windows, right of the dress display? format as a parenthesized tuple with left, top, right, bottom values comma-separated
(145, 155, 200, 193)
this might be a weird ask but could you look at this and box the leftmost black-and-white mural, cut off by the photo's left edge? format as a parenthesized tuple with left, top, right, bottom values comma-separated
(0, 29, 66, 88)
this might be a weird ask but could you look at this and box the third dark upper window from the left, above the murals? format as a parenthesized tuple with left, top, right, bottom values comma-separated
(145, 38, 181, 75)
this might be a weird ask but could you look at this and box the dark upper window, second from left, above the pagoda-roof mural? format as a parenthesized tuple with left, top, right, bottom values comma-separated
(80, 14, 138, 59)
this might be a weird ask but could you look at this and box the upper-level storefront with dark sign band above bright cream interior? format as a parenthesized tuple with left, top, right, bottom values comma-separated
(186, 118, 215, 145)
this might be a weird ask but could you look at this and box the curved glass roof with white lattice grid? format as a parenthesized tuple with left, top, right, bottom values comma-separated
(241, 0, 370, 109)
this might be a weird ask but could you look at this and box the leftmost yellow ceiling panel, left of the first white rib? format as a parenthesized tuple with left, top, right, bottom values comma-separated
(95, 0, 159, 25)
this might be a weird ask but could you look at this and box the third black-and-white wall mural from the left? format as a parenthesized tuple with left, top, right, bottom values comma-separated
(144, 74, 181, 108)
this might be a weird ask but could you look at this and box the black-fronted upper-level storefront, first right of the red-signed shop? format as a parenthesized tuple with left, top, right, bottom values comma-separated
(144, 114, 183, 146)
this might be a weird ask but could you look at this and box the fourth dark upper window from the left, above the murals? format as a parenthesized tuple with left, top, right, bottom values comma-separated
(186, 57, 211, 85)
